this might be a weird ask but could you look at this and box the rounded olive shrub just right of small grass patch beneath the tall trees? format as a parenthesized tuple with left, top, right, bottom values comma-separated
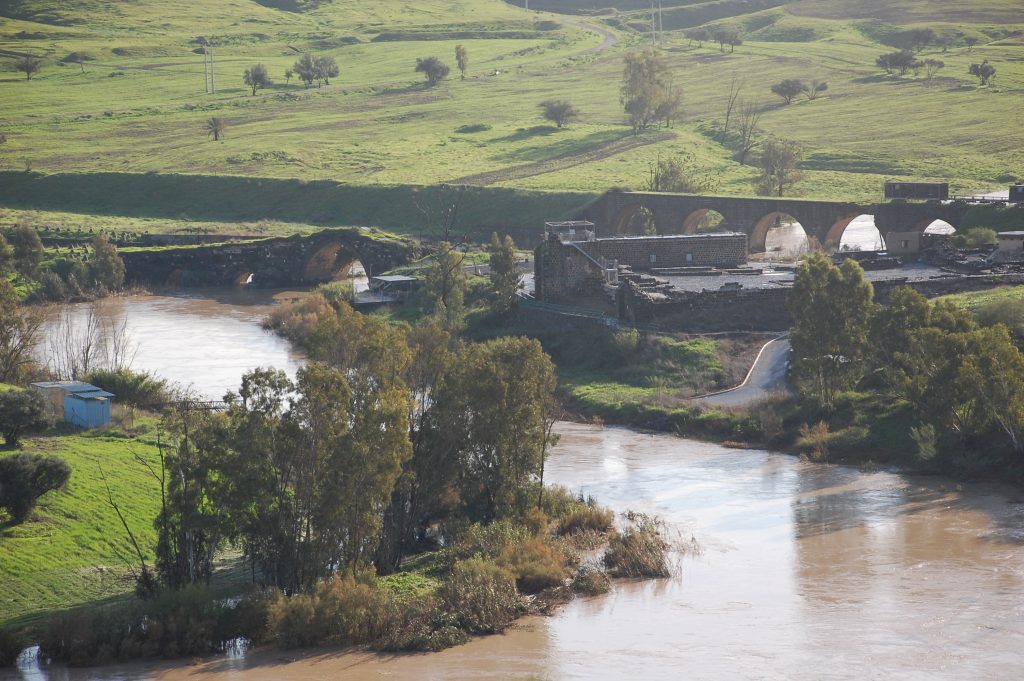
(440, 556, 522, 634)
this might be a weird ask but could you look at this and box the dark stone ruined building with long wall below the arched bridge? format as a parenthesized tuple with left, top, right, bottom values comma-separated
(534, 231, 746, 301)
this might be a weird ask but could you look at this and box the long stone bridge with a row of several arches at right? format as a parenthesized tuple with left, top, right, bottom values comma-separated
(581, 190, 971, 252)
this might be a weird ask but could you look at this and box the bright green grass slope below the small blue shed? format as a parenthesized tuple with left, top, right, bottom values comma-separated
(0, 422, 160, 626)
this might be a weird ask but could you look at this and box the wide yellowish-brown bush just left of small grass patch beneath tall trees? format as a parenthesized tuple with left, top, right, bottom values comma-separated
(267, 574, 395, 648)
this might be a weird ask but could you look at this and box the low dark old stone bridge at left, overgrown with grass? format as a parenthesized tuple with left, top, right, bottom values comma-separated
(121, 229, 415, 288)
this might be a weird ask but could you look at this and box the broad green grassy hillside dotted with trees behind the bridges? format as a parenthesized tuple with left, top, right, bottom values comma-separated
(0, 0, 1024, 231)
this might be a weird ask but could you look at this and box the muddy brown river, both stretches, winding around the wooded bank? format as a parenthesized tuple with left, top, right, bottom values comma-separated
(9, 294, 1024, 681)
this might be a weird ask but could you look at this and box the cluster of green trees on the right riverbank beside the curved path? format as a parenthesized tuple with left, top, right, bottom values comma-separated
(790, 253, 1024, 464)
